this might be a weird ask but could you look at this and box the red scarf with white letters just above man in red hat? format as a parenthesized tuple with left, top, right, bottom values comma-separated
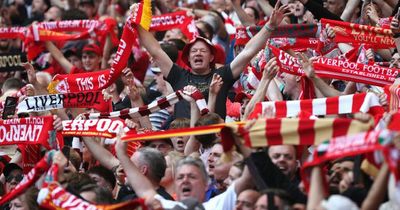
(150, 11, 199, 40)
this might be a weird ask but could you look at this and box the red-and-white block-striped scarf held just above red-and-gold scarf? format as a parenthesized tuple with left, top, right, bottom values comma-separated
(249, 93, 384, 119)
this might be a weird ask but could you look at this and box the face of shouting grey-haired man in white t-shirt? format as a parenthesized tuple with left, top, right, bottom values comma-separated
(175, 164, 207, 202)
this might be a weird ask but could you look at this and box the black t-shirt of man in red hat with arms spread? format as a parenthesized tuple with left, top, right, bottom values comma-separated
(166, 64, 236, 119)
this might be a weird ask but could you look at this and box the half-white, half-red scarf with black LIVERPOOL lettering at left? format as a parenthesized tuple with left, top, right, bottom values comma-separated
(17, 91, 111, 113)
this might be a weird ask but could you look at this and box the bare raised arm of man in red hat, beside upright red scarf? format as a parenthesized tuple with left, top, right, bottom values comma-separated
(139, 26, 173, 78)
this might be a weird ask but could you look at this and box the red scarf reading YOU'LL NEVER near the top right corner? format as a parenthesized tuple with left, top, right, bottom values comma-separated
(321, 18, 395, 49)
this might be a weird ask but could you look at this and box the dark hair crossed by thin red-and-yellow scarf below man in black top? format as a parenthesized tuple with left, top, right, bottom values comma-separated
(195, 112, 221, 148)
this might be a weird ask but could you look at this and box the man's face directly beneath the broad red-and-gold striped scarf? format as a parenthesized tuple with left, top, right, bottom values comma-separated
(268, 145, 297, 178)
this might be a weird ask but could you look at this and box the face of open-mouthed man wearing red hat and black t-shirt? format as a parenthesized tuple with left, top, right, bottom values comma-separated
(189, 41, 214, 74)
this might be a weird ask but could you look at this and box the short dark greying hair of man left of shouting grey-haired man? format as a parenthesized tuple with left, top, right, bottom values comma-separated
(136, 147, 167, 183)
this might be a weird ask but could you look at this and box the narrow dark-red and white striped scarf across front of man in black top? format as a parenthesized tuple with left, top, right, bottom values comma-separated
(85, 90, 209, 119)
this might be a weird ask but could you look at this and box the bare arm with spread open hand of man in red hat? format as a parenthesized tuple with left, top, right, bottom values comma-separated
(231, 1, 290, 78)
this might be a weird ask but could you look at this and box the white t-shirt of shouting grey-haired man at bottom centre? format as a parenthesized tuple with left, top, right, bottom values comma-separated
(154, 183, 237, 210)
